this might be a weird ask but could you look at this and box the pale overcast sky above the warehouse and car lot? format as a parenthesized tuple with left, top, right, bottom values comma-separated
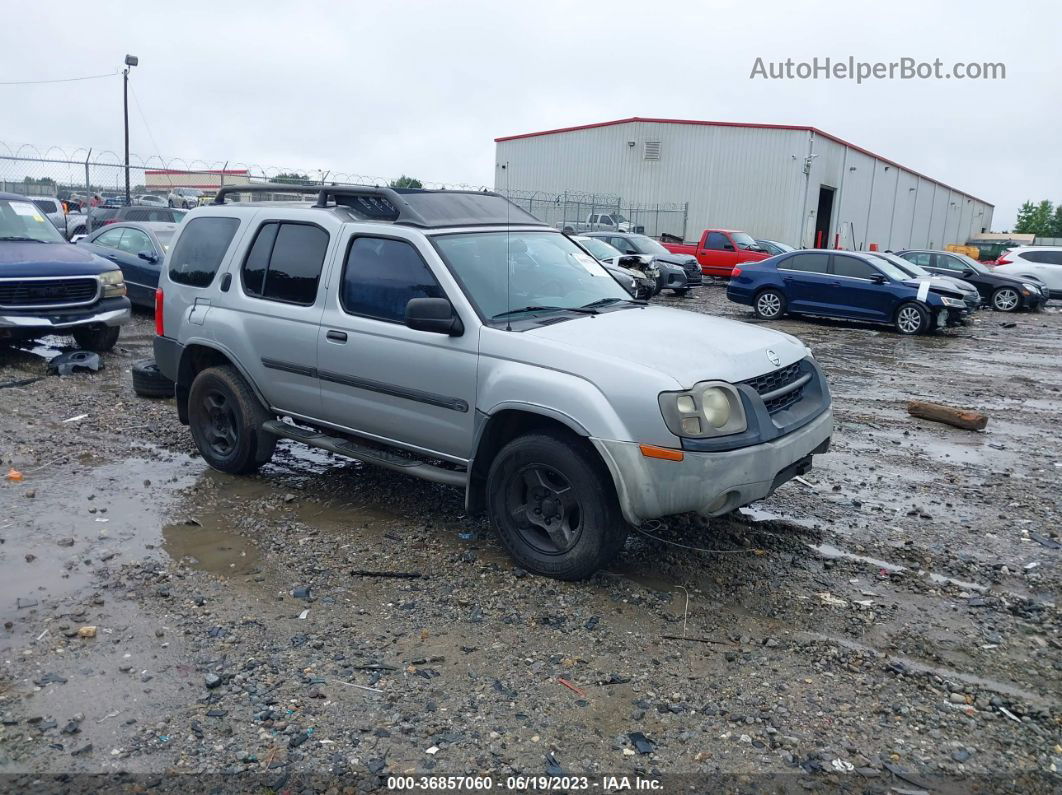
(0, 0, 1062, 230)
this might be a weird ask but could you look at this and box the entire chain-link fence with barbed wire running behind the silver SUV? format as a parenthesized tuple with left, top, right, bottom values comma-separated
(0, 142, 688, 239)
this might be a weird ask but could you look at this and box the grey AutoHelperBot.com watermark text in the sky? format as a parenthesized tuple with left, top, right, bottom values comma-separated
(749, 55, 1007, 84)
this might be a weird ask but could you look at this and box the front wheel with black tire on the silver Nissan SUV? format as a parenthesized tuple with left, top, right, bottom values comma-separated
(486, 433, 628, 580)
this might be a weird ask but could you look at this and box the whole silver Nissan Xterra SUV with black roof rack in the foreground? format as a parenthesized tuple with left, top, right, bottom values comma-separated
(155, 185, 833, 580)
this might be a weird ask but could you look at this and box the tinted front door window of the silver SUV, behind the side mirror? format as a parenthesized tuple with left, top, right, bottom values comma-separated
(340, 238, 446, 323)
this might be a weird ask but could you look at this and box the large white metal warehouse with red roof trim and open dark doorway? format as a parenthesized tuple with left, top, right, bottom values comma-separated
(495, 117, 993, 250)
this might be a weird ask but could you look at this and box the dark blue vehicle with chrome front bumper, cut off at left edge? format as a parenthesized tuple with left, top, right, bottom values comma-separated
(0, 193, 130, 351)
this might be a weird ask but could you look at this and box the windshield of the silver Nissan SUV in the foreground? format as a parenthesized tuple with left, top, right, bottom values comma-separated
(433, 231, 631, 318)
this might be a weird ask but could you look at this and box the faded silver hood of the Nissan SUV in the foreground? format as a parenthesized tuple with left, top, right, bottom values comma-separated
(523, 306, 808, 388)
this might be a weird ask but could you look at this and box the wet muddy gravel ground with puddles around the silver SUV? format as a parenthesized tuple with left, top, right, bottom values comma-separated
(0, 295, 1062, 792)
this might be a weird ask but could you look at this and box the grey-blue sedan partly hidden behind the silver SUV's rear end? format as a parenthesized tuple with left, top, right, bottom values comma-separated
(78, 222, 177, 309)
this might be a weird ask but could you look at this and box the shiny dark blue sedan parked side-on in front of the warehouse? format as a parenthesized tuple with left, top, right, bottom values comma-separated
(726, 249, 969, 334)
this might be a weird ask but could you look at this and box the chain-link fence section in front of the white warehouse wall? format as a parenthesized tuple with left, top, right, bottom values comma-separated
(500, 190, 689, 239)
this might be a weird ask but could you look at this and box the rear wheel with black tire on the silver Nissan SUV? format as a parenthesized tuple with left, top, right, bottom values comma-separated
(188, 365, 276, 474)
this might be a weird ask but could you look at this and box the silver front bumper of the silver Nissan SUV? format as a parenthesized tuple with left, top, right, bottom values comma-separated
(590, 408, 834, 524)
